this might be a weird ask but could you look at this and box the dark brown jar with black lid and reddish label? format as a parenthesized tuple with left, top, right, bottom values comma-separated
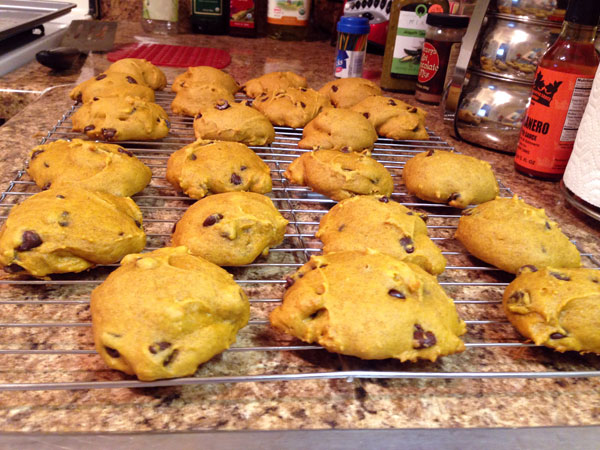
(415, 13, 469, 105)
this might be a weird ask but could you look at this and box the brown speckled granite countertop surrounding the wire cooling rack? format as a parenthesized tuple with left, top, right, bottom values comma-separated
(0, 22, 600, 432)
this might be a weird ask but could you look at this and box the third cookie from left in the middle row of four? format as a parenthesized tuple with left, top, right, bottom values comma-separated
(283, 150, 394, 201)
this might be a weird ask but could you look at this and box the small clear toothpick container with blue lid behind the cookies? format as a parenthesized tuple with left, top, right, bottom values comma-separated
(333, 16, 371, 78)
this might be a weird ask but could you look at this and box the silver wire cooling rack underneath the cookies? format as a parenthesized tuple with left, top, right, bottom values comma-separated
(0, 92, 600, 390)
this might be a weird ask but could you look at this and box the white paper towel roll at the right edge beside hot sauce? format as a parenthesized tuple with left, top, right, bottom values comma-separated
(563, 67, 600, 207)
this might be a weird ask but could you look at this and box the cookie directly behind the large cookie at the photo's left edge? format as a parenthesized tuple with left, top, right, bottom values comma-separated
(27, 139, 152, 197)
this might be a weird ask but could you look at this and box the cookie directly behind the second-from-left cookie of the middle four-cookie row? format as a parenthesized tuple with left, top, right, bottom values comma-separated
(194, 101, 275, 145)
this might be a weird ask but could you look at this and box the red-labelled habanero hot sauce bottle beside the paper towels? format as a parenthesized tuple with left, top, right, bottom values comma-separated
(515, 0, 600, 181)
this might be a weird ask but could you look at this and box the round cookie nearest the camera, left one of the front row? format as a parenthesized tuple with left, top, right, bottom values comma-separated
(91, 247, 250, 381)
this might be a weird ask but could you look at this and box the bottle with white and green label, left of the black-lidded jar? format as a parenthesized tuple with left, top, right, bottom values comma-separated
(380, 0, 449, 92)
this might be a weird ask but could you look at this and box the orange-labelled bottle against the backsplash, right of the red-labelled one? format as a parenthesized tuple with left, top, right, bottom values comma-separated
(267, 0, 310, 41)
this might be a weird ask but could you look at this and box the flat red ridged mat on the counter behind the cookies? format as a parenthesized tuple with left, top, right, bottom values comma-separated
(106, 44, 231, 69)
